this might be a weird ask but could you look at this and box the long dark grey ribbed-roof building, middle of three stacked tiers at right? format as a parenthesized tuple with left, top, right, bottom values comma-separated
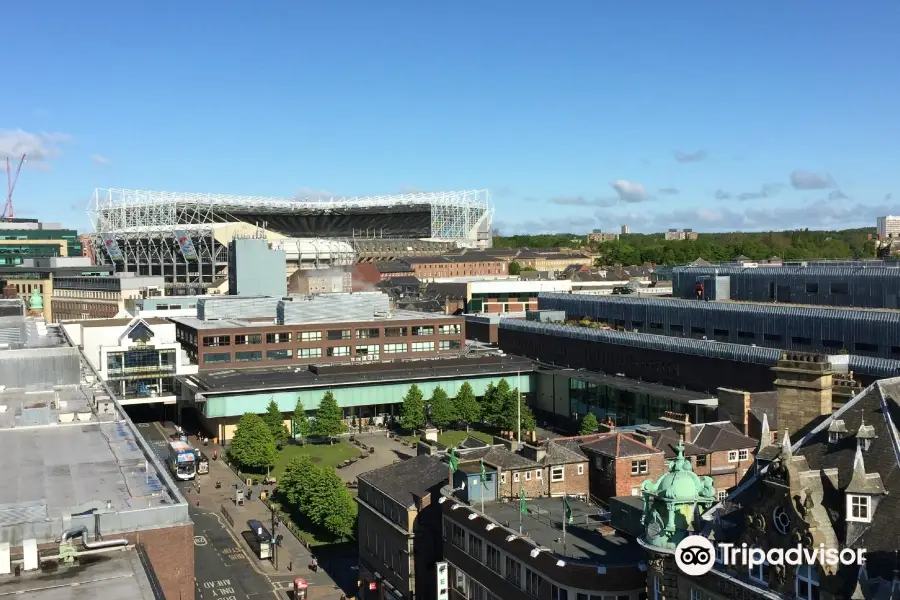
(538, 294, 900, 359)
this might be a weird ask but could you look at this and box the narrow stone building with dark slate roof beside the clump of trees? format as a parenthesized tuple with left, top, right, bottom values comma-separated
(356, 455, 449, 600)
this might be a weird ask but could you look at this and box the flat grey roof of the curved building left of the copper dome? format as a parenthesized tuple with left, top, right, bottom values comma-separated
(476, 498, 645, 565)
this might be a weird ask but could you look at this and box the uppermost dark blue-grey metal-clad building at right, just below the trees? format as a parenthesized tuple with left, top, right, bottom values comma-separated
(672, 263, 900, 308)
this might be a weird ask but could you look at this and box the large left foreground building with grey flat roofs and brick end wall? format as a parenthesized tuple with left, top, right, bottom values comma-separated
(0, 317, 195, 600)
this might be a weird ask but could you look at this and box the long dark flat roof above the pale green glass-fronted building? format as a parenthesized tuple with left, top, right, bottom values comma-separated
(180, 355, 535, 395)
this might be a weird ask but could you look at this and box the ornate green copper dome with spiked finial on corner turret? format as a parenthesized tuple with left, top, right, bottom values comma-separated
(641, 441, 716, 550)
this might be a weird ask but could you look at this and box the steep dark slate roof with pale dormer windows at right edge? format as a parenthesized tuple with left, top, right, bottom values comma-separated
(713, 377, 900, 599)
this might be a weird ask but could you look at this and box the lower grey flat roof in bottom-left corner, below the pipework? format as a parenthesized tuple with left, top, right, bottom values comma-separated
(0, 549, 162, 600)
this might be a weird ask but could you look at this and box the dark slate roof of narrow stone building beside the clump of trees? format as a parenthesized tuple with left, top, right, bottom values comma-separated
(358, 454, 449, 507)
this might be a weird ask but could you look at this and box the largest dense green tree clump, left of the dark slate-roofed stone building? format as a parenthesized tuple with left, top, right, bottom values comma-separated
(278, 456, 356, 538)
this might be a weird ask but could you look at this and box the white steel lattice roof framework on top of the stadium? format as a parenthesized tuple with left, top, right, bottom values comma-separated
(88, 188, 493, 247)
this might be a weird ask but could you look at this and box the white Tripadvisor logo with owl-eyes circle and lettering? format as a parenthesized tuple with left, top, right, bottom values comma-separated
(675, 535, 866, 577)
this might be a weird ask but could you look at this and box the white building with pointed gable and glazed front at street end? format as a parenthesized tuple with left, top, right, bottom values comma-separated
(62, 317, 198, 405)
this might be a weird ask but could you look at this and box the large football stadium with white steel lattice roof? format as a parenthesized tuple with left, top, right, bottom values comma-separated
(88, 189, 493, 293)
